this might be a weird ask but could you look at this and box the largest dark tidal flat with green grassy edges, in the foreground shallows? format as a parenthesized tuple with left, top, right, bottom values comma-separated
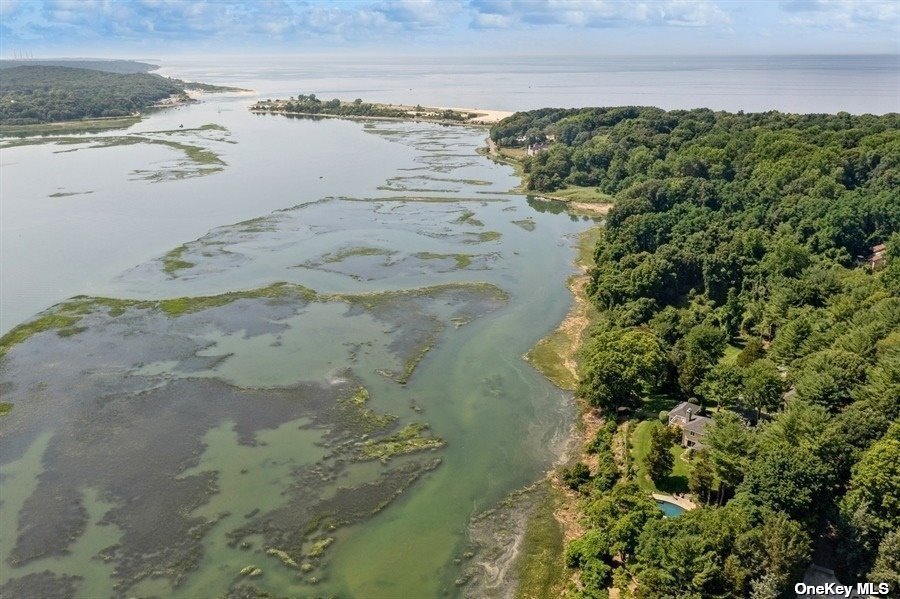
(0, 284, 506, 594)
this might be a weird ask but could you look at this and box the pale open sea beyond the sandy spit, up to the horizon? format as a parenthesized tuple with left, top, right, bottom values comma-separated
(157, 54, 900, 114)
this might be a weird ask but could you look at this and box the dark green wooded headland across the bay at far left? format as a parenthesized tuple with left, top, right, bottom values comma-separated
(0, 66, 184, 125)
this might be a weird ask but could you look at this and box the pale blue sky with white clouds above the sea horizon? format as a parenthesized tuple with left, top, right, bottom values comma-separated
(0, 0, 900, 58)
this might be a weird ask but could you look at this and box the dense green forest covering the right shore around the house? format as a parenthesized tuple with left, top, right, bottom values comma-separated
(491, 107, 900, 599)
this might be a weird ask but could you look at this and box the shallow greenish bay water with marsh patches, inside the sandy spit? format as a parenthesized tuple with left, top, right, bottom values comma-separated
(0, 103, 589, 597)
